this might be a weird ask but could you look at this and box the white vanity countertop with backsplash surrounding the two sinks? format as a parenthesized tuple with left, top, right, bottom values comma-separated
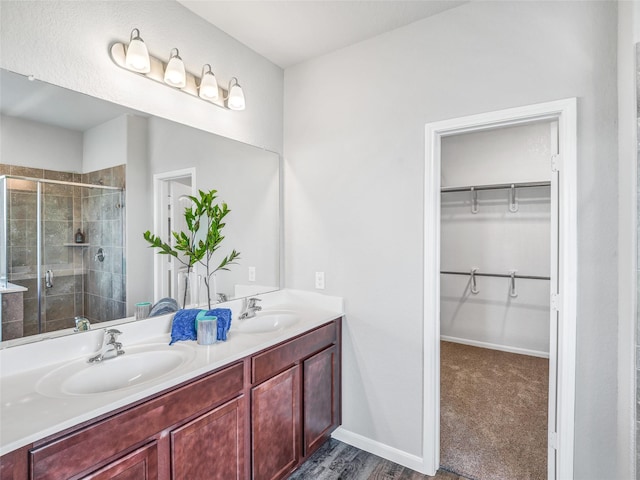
(0, 290, 343, 455)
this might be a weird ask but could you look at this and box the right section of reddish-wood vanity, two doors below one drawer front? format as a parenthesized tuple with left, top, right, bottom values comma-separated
(251, 319, 341, 480)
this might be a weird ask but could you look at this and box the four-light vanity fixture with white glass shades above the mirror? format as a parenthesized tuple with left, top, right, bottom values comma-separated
(109, 28, 245, 110)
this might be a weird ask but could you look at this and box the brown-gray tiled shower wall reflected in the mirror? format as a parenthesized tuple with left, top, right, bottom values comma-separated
(0, 164, 126, 340)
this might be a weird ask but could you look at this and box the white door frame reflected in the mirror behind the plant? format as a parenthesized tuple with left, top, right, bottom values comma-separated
(153, 168, 197, 302)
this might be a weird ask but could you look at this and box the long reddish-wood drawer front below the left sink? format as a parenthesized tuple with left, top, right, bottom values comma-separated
(29, 363, 244, 480)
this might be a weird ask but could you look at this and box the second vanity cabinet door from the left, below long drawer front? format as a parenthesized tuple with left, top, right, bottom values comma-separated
(171, 396, 245, 480)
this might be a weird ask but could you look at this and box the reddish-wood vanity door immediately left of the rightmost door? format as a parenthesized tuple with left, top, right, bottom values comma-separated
(251, 365, 300, 480)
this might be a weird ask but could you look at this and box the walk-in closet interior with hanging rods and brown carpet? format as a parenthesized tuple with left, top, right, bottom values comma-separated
(440, 121, 558, 480)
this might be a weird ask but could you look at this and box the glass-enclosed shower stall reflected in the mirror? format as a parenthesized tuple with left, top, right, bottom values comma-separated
(0, 174, 126, 341)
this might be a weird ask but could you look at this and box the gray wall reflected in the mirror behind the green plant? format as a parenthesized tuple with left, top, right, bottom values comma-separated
(149, 118, 280, 301)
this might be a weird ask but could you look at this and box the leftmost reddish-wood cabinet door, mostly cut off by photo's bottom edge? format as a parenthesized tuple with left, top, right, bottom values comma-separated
(84, 442, 158, 480)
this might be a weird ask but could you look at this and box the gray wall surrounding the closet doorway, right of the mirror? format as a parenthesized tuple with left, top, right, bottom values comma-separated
(284, 2, 617, 479)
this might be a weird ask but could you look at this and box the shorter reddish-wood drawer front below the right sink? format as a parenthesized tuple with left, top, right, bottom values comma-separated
(251, 322, 337, 384)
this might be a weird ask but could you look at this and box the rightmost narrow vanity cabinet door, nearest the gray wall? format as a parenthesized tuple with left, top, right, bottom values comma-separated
(303, 345, 340, 456)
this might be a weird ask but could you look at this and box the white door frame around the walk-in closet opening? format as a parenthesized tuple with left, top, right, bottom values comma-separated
(422, 98, 577, 480)
